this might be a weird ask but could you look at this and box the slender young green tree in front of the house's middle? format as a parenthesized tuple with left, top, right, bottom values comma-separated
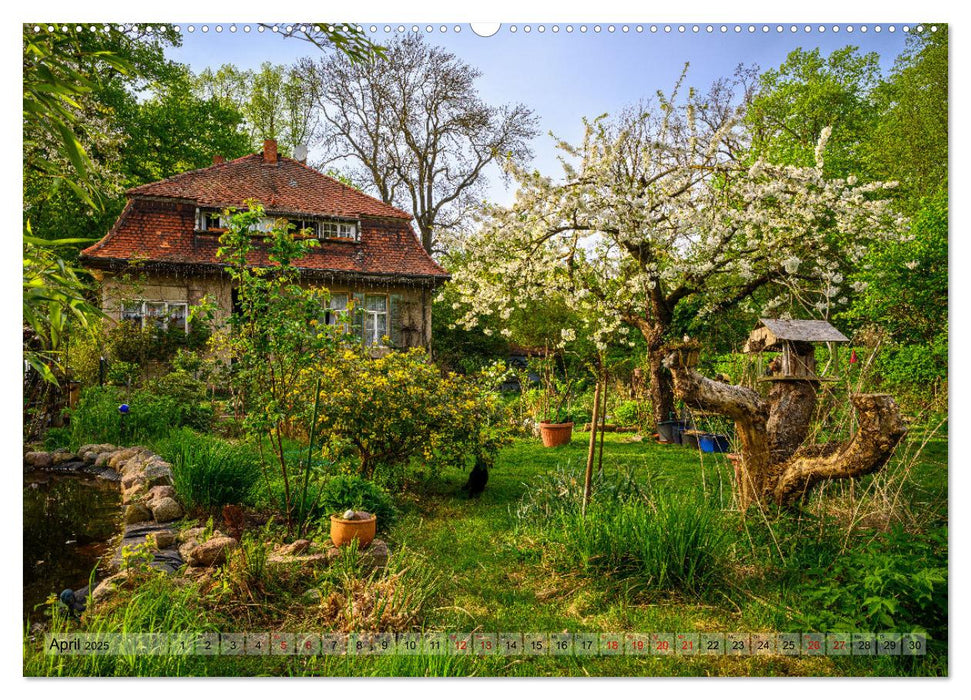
(217, 201, 340, 536)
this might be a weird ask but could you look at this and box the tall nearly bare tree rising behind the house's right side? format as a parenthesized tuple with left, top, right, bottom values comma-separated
(301, 34, 536, 252)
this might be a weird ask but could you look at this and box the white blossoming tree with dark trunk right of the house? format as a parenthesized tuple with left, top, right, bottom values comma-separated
(453, 78, 902, 420)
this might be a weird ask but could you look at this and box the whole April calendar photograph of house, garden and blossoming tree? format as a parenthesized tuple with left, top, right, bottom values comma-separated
(20, 17, 949, 677)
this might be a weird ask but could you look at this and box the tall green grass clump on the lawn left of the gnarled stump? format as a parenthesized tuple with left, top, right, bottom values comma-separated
(517, 471, 726, 594)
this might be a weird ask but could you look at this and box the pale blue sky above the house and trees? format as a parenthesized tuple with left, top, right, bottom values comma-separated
(168, 23, 906, 202)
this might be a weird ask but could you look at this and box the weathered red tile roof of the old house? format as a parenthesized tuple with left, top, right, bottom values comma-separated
(81, 153, 448, 279)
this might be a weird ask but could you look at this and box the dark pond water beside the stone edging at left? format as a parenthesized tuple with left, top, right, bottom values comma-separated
(24, 472, 121, 621)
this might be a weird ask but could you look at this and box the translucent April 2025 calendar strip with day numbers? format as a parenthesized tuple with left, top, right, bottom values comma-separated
(44, 632, 928, 657)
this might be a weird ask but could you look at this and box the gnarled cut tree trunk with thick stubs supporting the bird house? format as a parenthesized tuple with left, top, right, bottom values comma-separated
(664, 349, 907, 510)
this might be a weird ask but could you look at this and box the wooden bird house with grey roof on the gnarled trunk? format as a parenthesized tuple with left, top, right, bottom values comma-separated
(743, 318, 850, 382)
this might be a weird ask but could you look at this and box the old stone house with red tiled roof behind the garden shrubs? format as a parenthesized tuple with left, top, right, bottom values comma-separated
(81, 141, 448, 353)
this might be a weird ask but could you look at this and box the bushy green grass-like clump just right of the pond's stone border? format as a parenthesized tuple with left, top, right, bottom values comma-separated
(156, 428, 260, 508)
